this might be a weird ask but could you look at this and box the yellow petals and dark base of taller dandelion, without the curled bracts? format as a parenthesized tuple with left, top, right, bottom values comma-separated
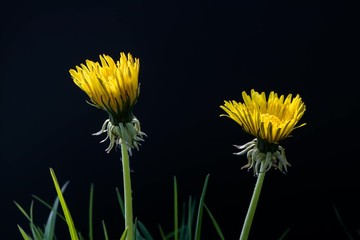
(69, 52, 140, 124)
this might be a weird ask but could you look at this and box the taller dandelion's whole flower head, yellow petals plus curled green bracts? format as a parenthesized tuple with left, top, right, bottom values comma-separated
(69, 52, 146, 154)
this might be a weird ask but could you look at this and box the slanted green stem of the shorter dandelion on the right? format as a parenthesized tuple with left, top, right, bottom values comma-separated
(240, 161, 266, 240)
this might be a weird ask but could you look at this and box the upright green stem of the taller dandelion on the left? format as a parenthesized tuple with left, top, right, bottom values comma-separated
(121, 141, 134, 240)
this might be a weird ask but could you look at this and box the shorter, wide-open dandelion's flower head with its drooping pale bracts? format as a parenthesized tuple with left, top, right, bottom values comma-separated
(220, 89, 306, 175)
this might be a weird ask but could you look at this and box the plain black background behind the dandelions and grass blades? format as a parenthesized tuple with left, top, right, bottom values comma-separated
(0, 0, 360, 240)
